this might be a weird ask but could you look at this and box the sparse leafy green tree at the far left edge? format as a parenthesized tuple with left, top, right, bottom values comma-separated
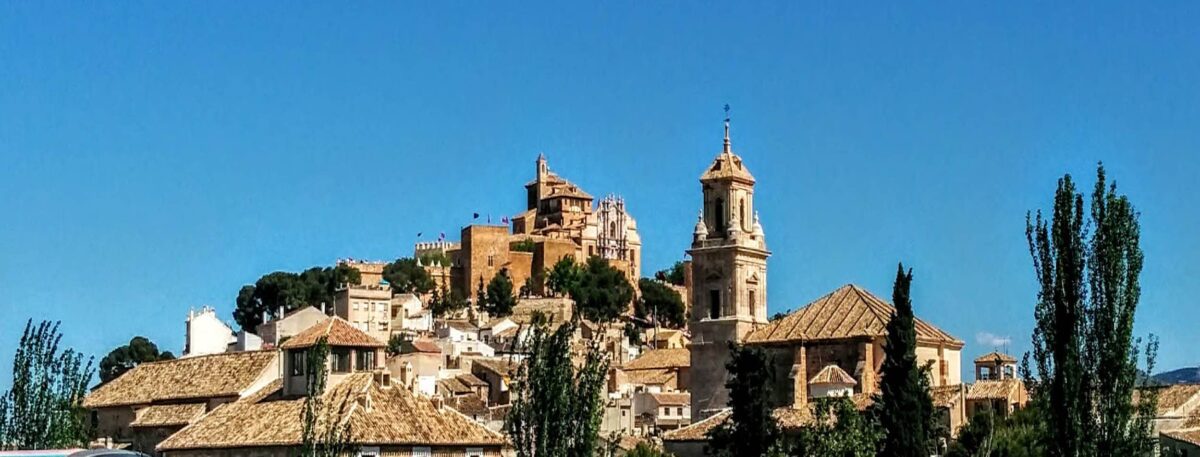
(0, 319, 92, 450)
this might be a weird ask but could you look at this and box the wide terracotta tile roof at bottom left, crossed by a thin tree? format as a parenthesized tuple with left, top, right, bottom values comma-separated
(157, 373, 505, 451)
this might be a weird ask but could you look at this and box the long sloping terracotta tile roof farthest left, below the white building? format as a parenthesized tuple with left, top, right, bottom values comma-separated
(83, 350, 276, 408)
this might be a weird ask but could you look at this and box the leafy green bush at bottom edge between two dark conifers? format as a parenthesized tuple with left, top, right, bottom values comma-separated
(791, 397, 883, 457)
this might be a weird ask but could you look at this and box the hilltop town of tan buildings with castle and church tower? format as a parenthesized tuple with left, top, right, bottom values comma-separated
(7, 121, 1200, 457)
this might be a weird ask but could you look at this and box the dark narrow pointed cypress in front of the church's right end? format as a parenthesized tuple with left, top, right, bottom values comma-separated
(877, 264, 934, 457)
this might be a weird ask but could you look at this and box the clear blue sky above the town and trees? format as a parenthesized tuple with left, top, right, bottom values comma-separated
(0, 1, 1200, 385)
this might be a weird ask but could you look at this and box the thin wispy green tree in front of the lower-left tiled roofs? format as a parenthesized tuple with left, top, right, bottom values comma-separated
(299, 337, 356, 457)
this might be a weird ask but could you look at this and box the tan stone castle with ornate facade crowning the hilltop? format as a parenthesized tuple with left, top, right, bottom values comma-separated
(414, 155, 642, 297)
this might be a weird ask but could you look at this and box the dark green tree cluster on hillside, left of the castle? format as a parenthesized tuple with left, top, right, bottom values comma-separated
(233, 265, 361, 332)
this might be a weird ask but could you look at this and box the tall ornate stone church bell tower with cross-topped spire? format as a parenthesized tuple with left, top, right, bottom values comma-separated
(688, 119, 770, 421)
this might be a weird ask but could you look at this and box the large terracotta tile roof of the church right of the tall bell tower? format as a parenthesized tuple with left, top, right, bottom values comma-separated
(746, 284, 962, 348)
